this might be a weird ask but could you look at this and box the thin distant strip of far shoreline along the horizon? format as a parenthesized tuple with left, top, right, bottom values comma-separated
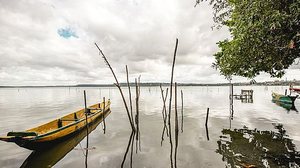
(0, 80, 300, 88)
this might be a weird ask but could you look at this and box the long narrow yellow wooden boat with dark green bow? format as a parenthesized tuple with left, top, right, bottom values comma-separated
(0, 100, 110, 150)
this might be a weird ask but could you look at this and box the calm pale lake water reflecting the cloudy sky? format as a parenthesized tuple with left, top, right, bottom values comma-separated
(0, 86, 300, 168)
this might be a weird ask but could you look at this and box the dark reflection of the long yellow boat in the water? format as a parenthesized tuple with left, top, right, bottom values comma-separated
(21, 110, 108, 168)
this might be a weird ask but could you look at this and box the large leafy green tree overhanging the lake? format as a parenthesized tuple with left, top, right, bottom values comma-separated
(197, 0, 300, 78)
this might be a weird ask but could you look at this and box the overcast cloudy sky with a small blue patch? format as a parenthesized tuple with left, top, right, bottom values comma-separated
(0, 0, 300, 85)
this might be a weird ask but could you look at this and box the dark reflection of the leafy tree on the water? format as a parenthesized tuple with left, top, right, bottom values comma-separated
(216, 124, 300, 167)
